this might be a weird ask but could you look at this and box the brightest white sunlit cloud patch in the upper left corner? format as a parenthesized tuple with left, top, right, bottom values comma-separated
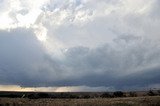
(0, 0, 48, 29)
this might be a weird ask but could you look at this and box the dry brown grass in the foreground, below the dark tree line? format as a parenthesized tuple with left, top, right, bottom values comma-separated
(0, 96, 160, 106)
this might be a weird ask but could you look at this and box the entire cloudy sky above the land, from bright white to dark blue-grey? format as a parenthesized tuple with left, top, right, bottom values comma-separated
(0, 0, 160, 91)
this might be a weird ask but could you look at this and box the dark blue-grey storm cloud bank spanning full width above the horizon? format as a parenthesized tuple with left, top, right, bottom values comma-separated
(0, 29, 160, 89)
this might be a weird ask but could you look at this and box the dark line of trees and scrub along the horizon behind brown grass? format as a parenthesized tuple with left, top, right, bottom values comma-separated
(0, 90, 160, 99)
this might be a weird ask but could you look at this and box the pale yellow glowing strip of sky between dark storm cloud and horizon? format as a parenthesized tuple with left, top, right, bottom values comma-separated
(0, 85, 114, 92)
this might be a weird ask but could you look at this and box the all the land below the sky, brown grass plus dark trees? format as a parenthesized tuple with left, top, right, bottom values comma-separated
(0, 91, 160, 106)
